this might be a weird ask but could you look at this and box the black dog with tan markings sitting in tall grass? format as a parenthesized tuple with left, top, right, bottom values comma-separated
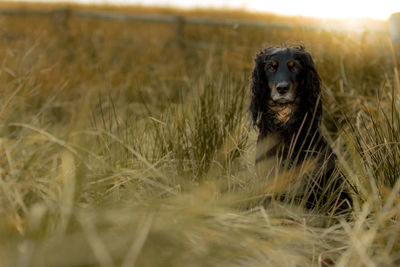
(250, 46, 351, 213)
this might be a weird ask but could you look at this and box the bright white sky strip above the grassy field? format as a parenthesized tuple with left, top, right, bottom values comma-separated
(15, 0, 400, 20)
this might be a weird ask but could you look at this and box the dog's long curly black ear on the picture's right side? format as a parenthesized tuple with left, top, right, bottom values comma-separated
(297, 47, 322, 123)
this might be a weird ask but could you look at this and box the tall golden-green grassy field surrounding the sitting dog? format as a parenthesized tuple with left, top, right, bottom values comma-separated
(0, 5, 400, 267)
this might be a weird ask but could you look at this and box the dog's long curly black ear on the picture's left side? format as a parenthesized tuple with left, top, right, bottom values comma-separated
(250, 48, 269, 129)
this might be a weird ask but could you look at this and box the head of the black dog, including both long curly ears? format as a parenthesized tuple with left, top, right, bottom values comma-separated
(250, 46, 322, 129)
